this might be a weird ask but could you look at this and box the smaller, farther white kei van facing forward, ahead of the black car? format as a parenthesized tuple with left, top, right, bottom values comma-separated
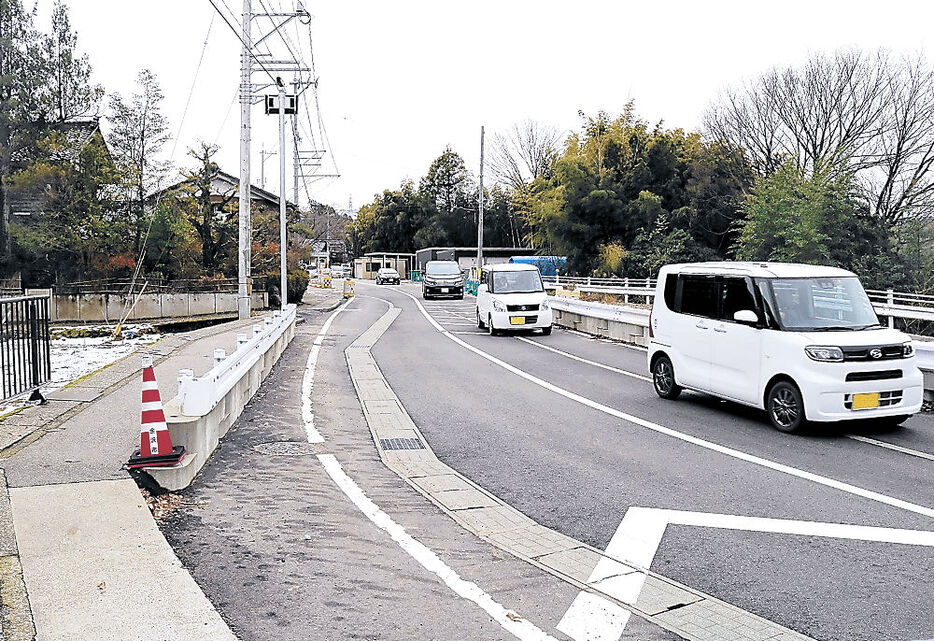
(477, 263, 552, 335)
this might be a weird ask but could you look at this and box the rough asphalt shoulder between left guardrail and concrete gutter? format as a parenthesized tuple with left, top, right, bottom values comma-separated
(161, 297, 677, 641)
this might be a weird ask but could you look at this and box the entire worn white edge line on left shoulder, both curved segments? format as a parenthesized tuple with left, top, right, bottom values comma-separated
(302, 296, 557, 641)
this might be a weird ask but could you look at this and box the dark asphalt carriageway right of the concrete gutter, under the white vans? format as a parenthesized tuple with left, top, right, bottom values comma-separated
(357, 283, 934, 641)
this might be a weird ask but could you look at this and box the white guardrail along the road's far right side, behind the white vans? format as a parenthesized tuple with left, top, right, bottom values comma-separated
(545, 278, 934, 371)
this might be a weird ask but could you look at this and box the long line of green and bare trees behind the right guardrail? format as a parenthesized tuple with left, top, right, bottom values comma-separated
(348, 50, 934, 291)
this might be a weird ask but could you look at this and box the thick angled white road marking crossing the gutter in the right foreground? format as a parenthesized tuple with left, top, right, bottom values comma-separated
(558, 507, 934, 641)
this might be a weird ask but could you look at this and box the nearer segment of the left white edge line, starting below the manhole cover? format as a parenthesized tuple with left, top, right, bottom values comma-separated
(318, 454, 555, 641)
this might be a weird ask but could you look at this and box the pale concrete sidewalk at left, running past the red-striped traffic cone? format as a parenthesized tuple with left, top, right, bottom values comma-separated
(0, 292, 340, 641)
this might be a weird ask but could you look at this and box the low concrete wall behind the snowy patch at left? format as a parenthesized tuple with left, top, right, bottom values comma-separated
(26, 290, 269, 323)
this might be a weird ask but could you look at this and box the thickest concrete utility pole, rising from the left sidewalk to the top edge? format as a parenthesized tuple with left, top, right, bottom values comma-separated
(237, 0, 253, 319)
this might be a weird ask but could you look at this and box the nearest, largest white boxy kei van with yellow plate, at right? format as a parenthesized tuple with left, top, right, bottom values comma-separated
(648, 262, 923, 432)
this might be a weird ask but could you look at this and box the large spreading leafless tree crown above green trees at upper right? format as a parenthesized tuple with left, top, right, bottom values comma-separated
(705, 51, 934, 224)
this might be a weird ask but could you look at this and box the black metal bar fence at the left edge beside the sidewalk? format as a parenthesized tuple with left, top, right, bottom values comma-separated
(0, 296, 52, 399)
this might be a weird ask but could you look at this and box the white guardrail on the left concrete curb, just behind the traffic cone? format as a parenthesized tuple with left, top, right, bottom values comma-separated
(178, 305, 295, 416)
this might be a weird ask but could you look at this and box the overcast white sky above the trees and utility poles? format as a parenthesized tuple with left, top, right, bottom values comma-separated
(56, 0, 934, 208)
